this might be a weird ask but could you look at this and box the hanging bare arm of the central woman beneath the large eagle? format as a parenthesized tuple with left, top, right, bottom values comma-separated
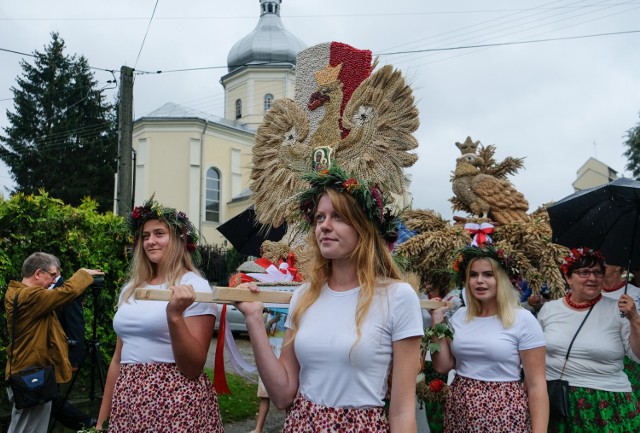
(389, 337, 421, 433)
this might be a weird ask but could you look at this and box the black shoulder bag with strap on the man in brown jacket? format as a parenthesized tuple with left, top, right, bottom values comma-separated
(8, 293, 58, 409)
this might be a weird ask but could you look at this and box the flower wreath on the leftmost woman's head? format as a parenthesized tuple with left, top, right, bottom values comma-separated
(129, 196, 200, 266)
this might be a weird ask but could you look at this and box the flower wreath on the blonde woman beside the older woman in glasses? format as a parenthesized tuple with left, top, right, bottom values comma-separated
(451, 244, 522, 288)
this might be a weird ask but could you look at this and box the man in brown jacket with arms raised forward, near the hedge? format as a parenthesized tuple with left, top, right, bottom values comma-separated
(4, 253, 103, 433)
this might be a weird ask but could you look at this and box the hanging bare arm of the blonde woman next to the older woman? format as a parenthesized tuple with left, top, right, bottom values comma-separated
(520, 347, 549, 433)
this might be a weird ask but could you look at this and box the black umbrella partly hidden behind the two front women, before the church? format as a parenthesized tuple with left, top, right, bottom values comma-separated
(218, 206, 287, 257)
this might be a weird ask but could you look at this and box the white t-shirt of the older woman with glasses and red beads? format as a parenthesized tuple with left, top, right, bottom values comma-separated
(538, 297, 638, 392)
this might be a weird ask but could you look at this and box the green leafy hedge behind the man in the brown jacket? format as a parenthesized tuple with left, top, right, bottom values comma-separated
(0, 191, 130, 398)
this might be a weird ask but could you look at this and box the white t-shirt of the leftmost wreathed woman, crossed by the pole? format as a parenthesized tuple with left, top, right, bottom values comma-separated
(113, 272, 218, 364)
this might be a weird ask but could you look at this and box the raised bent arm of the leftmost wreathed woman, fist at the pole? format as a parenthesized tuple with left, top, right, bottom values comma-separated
(167, 285, 216, 379)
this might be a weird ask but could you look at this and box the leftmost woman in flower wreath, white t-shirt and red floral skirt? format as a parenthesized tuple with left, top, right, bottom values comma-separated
(98, 197, 223, 433)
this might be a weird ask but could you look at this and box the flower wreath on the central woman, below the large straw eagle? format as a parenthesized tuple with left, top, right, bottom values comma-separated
(298, 164, 400, 242)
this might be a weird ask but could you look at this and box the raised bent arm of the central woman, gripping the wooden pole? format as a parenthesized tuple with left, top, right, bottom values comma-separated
(237, 302, 300, 410)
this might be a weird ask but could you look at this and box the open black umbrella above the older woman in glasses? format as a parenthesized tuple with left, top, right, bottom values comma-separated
(548, 178, 640, 270)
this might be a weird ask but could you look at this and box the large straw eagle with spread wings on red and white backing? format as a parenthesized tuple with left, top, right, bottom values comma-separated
(250, 42, 419, 227)
